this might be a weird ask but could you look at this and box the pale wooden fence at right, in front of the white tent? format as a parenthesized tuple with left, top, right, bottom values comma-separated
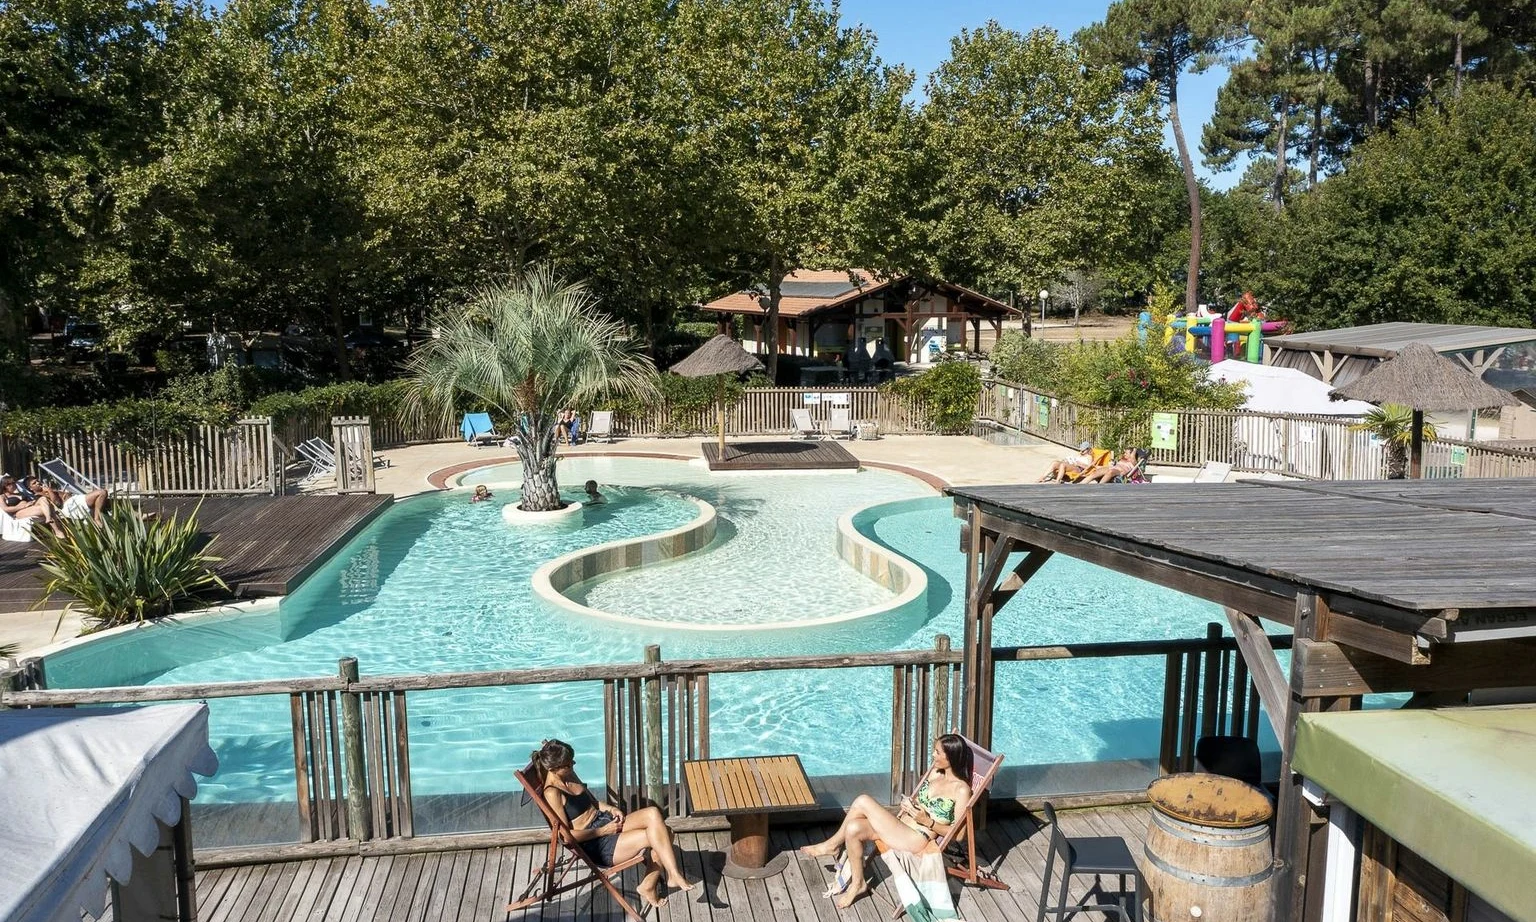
(977, 381, 1536, 479)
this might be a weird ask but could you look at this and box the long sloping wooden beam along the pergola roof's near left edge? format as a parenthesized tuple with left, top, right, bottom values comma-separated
(971, 504, 1295, 624)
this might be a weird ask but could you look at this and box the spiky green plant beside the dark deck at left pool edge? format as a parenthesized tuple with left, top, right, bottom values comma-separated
(32, 502, 229, 628)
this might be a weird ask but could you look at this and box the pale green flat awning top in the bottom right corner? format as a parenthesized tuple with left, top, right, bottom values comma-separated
(1292, 705, 1536, 922)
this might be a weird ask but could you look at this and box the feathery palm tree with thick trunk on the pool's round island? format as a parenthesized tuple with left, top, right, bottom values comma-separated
(406, 266, 656, 512)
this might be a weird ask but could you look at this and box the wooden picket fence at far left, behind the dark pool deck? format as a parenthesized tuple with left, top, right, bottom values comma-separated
(0, 416, 283, 495)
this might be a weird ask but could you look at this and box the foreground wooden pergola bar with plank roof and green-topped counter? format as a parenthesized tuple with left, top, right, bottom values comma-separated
(951, 479, 1536, 922)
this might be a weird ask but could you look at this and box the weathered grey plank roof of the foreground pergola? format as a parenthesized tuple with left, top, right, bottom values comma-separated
(951, 478, 1536, 639)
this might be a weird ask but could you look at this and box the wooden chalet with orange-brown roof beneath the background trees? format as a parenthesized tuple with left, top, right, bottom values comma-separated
(703, 269, 1020, 361)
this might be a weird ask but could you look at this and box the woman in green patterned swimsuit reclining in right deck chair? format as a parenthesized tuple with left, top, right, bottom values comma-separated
(803, 733, 972, 910)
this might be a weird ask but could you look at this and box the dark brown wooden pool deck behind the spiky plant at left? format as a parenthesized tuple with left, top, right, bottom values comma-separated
(0, 493, 395, 607)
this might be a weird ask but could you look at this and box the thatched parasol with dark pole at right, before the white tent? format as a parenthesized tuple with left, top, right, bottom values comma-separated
(1332, 343, 1519, 478)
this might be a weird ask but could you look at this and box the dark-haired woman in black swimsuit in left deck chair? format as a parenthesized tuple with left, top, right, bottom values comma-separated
(533, 739, 697, 907)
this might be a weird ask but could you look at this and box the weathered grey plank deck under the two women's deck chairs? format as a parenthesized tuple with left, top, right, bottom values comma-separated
(188, 807, 1146, 922)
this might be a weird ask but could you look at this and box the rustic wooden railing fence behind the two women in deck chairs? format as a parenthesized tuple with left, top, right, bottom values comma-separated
(0, 624, 1289, 861)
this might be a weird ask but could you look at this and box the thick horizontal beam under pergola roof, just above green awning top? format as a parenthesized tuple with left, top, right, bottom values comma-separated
(1290, 639, 1536, 698)
